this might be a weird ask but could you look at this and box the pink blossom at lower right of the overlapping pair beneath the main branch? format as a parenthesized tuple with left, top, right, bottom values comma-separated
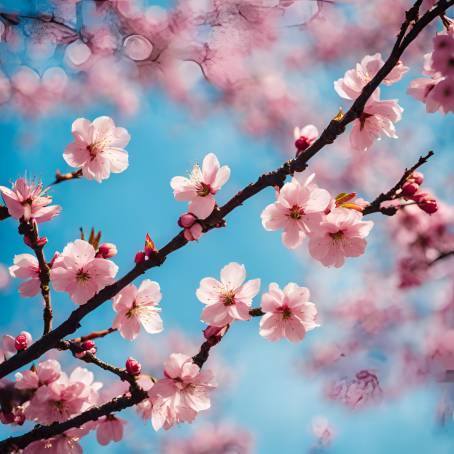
(309, 208, 374, 268)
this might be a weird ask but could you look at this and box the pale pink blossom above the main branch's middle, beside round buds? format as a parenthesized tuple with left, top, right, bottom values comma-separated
(170, 153, 230, 219)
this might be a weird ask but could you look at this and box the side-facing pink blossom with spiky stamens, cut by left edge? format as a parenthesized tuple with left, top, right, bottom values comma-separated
(0, 178, 61, 224)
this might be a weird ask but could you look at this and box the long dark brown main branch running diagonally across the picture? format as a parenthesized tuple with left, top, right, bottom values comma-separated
(0, 0, 454, 384)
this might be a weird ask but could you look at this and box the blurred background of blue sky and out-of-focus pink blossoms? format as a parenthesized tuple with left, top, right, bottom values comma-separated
(0, 0, 454, 454)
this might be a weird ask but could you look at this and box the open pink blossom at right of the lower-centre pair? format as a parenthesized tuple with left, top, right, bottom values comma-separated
(260, 282, 320, 342)
